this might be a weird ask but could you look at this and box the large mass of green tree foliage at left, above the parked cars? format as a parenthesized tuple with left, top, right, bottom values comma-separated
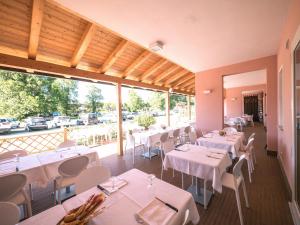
(0, 70, 78, 120)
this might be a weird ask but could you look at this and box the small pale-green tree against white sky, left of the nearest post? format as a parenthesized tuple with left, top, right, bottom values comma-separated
(86, 85, 103, 113)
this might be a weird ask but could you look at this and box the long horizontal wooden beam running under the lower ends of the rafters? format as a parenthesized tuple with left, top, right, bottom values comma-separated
(0, 53, 191, 94)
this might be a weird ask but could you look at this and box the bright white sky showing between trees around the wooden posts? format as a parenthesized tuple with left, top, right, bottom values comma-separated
(78, 81, 156, 103)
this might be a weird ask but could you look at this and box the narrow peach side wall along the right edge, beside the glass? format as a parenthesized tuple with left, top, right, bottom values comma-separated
(277, 0, 300, 190)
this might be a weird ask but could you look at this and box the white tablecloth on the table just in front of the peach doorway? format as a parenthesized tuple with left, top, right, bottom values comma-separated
(197, 132, 245, 158)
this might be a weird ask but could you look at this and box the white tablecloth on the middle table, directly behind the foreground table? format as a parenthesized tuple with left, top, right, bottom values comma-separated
(163, 145, 232, 193)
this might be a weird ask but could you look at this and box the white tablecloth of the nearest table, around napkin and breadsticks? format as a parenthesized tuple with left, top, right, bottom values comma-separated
(62, 169, 200, 225)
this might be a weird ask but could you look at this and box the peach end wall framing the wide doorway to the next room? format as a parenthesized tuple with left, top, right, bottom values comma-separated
(195, 55, 277, 151)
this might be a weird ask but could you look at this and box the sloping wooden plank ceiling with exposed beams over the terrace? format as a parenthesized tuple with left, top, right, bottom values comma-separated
(0, 0, 195, 95)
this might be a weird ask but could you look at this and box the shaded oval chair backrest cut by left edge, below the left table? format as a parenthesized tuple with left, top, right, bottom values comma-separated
(0, 173, 27, 201)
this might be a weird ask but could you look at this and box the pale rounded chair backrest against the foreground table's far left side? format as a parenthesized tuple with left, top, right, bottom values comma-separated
(75, 166, 111, 194)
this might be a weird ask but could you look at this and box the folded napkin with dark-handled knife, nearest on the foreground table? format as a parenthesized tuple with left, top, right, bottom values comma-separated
(136, 198, 176, 225)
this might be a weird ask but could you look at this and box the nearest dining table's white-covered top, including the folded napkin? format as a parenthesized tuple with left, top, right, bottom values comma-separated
(19, 169, 200, 225)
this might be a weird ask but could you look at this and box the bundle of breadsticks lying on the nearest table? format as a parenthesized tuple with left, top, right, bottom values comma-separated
(57, 193, 105, 225)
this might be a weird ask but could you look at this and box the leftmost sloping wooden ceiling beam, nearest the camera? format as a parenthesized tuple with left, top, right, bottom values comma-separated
(28, 0, 44, 59)
